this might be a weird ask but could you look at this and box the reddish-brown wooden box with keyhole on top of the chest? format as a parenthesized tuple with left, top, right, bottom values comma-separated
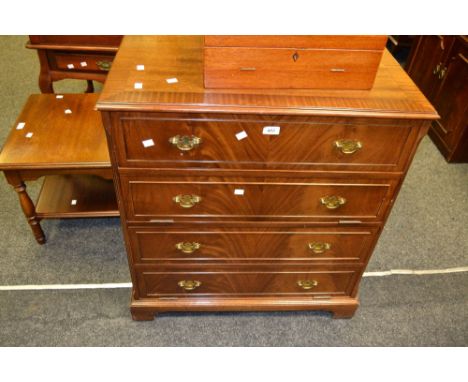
(204, 36, 387, 90)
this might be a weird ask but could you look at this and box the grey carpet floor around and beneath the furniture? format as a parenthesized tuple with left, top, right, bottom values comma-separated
(0, 36, 468, 346)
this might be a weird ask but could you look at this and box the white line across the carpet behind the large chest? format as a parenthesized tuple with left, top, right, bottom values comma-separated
(0, 267, 468, 291)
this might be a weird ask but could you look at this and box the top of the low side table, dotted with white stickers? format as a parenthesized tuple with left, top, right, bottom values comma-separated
(0, 94, 110, 170)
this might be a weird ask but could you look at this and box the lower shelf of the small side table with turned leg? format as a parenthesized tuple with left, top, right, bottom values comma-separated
(36, 175, 120, 219)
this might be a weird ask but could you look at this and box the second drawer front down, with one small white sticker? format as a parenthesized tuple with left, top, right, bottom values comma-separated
(121, 176, 394, 221)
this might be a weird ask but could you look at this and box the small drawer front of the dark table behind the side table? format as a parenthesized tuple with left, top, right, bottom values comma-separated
(49, 52, 114, 73)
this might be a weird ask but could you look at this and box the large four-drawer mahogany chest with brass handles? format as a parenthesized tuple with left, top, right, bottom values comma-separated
(98, 36, 437, 320)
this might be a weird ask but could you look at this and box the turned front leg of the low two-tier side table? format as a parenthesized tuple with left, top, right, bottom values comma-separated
(5, 171, 46, 244)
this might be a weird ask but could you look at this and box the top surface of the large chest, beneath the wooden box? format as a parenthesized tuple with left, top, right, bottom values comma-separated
(97, 36, 438, 119)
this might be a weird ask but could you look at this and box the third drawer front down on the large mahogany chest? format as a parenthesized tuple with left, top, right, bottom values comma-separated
(128, 227, 376, 263)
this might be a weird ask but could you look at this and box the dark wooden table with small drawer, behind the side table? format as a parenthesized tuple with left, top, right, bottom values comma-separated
(26, 35, 122, 93)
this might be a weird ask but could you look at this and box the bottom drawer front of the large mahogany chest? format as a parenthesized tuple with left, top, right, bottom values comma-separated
(136, 270, 357, 297)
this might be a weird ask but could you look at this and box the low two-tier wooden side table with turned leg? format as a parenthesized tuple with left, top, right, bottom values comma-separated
(0, 94, 114, 244)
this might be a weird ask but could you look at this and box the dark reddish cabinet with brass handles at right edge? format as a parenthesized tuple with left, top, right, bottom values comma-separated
(406, 36, 468, 162)
